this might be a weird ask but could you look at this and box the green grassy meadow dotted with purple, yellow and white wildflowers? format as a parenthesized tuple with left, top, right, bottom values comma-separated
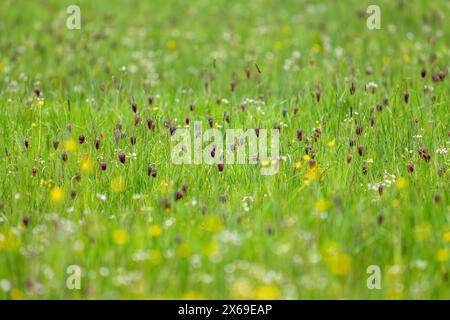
(0, 0, 450, 299)
